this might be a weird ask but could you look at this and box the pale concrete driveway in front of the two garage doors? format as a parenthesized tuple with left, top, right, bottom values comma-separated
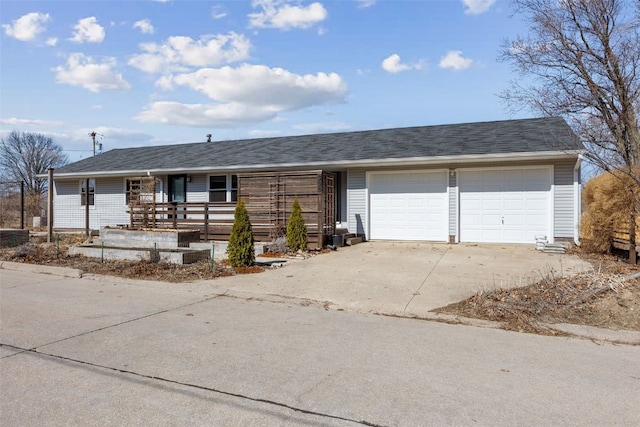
(207, 241, 591, 317)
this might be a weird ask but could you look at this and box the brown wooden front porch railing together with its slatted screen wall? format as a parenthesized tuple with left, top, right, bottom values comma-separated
(127, 170, 339, 249)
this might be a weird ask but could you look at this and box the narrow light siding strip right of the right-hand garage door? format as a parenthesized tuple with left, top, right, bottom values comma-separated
(553, 161, 576, 239)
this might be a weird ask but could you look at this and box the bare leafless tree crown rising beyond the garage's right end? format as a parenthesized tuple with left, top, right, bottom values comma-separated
(499, 0, 640, 192)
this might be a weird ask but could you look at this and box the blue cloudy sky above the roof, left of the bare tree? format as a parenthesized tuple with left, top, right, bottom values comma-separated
(0, 0, 530, 160)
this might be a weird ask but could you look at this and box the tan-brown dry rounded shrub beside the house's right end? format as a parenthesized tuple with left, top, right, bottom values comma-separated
(581, 172, 638, 253)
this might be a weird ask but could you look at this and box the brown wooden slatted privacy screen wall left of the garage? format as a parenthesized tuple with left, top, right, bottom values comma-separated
(238, 170, 335, 249)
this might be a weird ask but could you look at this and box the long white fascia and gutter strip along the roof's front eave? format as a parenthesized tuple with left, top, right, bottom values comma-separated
(45, 150, 583, 179)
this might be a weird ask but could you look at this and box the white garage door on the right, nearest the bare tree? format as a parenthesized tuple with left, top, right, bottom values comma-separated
(458, 168, 551, 243)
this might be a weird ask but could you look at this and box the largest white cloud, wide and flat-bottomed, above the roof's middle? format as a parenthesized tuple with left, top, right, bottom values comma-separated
(136, 65, 347, 127)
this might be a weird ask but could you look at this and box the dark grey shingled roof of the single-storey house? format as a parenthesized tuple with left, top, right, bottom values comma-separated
(56, 117, 583, 175)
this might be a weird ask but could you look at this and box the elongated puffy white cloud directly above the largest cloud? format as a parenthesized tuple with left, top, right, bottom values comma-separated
(129, 32, 251, 73)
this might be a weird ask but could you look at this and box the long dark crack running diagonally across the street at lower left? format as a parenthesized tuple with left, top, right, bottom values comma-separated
(5, 346, 383, 427)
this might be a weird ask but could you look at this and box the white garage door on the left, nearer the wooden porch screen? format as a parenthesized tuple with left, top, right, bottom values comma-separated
(369, 171, 448, 241)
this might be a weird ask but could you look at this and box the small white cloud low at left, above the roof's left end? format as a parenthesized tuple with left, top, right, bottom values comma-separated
(51, 53, 131, 92)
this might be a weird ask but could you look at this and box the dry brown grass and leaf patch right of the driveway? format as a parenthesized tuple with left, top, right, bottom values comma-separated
(436, 254, 640, 335)
